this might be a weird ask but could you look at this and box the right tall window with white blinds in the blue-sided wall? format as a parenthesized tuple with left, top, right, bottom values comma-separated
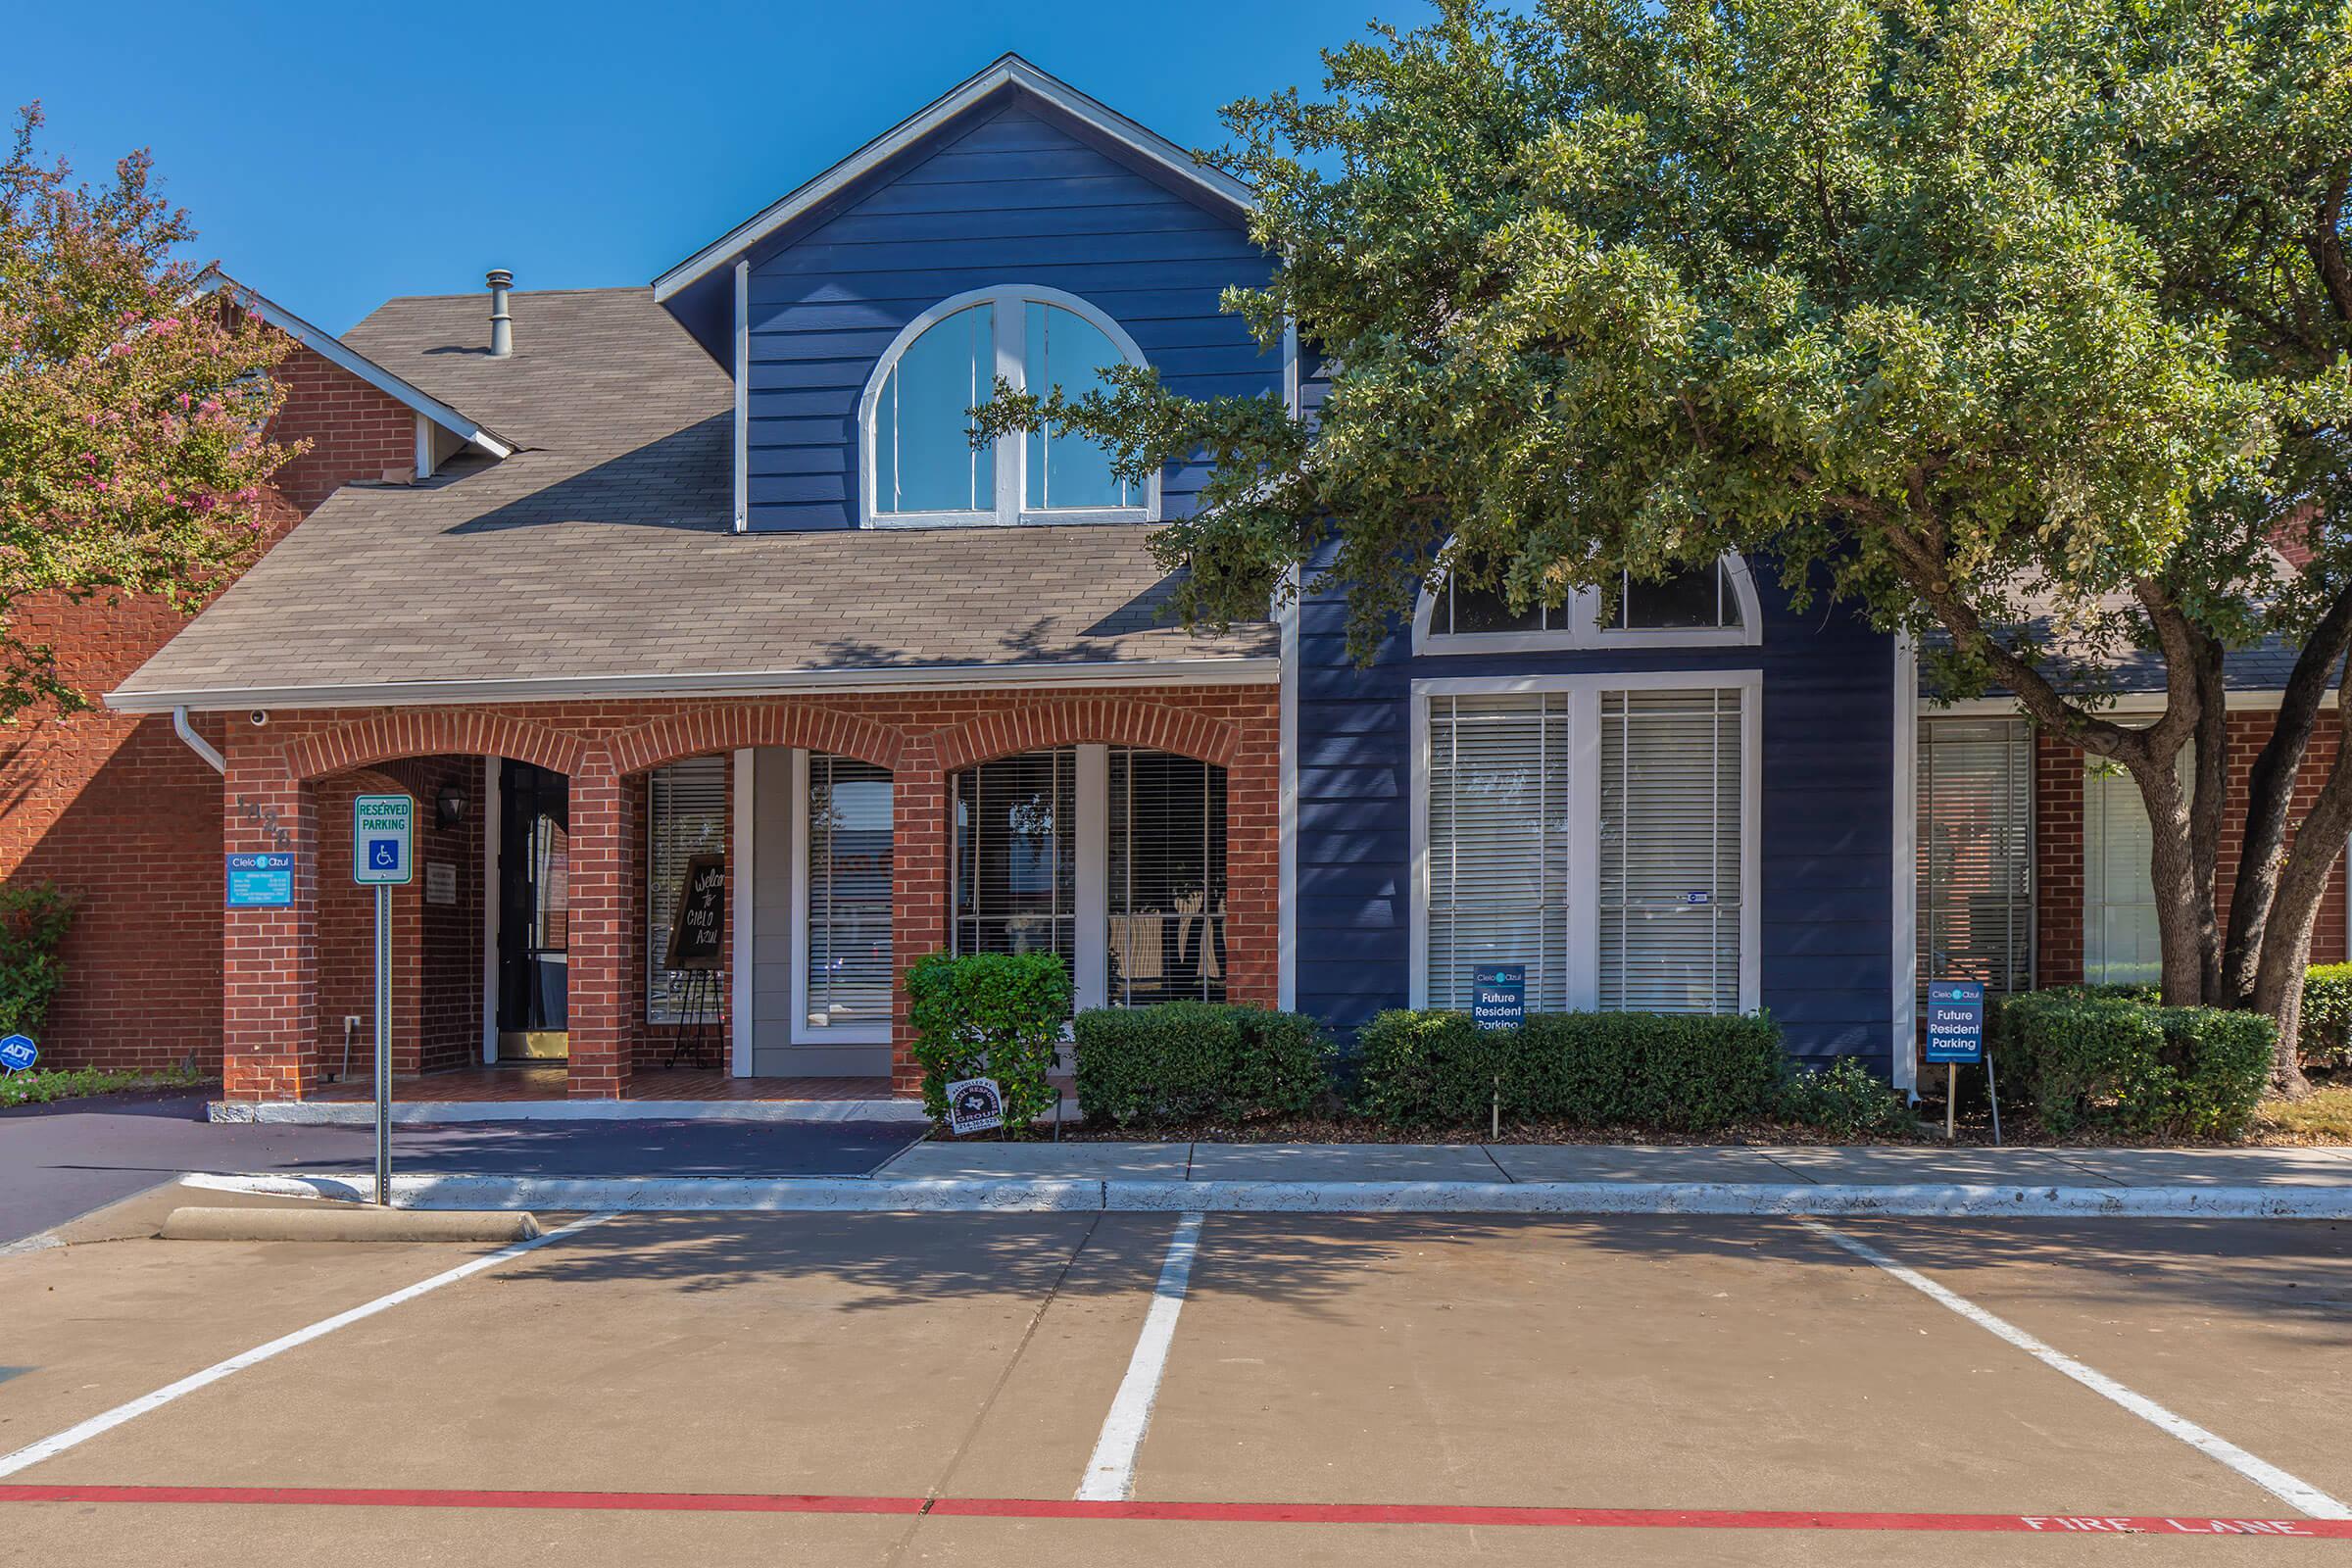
(1597, 689, 1745, 1013)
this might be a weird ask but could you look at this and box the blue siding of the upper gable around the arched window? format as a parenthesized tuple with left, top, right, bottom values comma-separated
(748, 96, 1282, 540)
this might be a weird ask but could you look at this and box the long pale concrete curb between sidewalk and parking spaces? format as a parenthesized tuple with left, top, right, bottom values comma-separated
(200, 1173, 2352, 1220)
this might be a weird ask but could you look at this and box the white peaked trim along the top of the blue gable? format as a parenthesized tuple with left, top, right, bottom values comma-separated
(654, 54, 1258, 301)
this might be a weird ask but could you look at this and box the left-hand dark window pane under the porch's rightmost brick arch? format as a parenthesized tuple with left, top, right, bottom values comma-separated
(955, 745, 1077, 964)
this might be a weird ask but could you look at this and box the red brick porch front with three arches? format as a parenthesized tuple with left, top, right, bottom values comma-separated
(221, 686, 1280, 1098)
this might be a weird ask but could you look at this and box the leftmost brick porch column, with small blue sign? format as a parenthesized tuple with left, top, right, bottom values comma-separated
(212, 745, 319, 1101)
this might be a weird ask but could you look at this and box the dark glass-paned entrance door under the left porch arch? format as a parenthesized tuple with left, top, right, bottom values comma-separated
(499, 761, 571, 1060)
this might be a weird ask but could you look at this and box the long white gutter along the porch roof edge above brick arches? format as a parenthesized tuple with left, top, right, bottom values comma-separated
(106, 656, 1282, 714)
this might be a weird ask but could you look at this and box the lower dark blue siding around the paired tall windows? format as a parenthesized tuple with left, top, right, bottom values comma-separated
(1296, 552, 1895, 1062)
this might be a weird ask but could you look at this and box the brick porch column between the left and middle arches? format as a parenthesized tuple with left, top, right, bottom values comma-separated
(564, 748, 635, 1101)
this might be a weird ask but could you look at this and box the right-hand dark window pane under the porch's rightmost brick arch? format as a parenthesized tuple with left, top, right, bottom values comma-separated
(1107, 745, 1225, 1006)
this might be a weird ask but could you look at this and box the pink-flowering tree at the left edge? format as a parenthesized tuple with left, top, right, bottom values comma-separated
(0, 104, 294, 721)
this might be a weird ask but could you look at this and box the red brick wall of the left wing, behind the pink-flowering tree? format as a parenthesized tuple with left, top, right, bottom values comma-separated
(0, 348, 416, 1067)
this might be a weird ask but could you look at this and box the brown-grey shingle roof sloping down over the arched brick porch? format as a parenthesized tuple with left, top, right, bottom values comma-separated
(116, 289, 1277, 708)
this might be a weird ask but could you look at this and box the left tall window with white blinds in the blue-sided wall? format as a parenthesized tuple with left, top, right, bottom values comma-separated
(1428, 691, 1569, 1010)
